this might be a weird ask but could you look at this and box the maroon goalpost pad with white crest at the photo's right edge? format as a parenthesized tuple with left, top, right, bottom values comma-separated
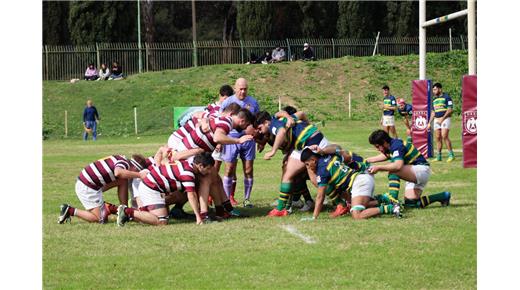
(462, 75, 477, 168)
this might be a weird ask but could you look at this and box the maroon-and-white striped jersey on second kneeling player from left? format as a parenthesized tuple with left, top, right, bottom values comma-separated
(143, 160, 195, 193)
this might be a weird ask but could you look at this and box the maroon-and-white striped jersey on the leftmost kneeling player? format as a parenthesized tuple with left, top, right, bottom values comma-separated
(79, 155, 130, 190)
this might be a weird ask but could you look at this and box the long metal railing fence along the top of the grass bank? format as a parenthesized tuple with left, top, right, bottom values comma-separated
(42, 36, 468, 80)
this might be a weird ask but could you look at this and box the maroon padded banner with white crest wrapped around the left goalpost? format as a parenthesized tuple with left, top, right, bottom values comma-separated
(411, 80, 433, 158)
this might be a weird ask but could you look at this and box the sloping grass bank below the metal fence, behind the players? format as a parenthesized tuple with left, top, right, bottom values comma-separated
(42, 51, 467, 138)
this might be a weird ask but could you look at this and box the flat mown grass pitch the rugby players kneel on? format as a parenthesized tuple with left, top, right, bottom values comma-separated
(43, 120, 477, 289)
